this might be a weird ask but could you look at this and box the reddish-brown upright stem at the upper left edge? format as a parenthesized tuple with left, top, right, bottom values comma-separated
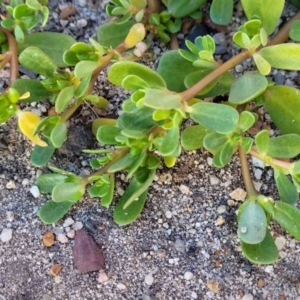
(0, 27, 19, 85)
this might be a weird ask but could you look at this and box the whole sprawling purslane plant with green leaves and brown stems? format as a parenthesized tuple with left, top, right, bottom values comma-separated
(0, 0, 300, 263)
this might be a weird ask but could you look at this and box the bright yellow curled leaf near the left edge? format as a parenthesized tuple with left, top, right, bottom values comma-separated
(17, 110, 48, 147)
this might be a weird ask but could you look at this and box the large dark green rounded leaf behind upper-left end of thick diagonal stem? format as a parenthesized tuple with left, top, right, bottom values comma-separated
(157, 50, 199, 93)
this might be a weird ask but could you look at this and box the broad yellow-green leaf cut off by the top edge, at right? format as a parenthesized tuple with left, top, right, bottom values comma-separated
(241, 0, 285, 35)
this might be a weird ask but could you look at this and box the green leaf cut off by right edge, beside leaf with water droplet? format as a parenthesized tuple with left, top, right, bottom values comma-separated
(272, 201, 300, 240)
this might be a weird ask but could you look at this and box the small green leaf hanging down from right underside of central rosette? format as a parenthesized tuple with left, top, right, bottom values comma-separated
(155, 127, 179, 156)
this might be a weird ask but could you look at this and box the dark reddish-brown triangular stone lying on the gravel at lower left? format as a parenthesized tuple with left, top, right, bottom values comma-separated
(73, 229, 104, 273)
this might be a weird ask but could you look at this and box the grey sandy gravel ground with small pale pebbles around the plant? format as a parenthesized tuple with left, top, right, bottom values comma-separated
(0, 0, 300, 300)
